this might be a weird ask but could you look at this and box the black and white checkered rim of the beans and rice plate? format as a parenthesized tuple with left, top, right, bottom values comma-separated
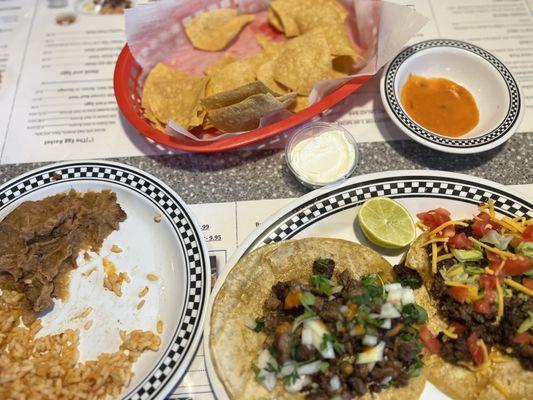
(0, 162, 211, 400)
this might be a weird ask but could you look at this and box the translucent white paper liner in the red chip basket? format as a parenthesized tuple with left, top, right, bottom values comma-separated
(125, 0, 428, 142)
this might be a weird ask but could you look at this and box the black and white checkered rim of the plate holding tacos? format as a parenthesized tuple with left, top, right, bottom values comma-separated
(243, 172, 533, 254)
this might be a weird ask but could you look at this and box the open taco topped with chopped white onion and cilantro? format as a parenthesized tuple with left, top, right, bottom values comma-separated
(209, 238, 427, 400)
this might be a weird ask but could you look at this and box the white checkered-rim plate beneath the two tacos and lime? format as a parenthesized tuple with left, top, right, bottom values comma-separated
(204, 171, 533, 400)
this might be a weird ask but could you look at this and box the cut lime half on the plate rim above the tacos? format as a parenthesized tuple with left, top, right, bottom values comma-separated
(358, 197, 416, 249)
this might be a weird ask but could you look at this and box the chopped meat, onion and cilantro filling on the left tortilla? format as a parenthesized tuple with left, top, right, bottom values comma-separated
(254, 259, 427, 400)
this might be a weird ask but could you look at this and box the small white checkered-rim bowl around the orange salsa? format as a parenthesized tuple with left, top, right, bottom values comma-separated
(380, 39, 524, 154)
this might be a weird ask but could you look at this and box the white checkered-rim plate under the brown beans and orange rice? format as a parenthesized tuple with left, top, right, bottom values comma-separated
(0, 161, 211, 399)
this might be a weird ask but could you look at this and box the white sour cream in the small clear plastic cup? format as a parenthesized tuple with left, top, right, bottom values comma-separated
(290, 131, 355, 185)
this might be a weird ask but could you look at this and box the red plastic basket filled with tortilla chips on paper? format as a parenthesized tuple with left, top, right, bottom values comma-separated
(114, 0, 426, 152)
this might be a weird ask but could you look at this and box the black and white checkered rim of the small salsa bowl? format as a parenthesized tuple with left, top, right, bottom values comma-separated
(385, 39, 521, 148)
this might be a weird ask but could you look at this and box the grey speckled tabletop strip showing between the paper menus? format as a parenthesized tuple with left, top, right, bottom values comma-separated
(0, 133, 533, 203)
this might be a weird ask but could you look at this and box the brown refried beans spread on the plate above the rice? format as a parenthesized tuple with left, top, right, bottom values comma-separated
(0, 190, 126, 323)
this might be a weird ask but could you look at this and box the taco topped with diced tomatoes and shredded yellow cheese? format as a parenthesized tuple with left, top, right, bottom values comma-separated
(405, 202, 533, 400)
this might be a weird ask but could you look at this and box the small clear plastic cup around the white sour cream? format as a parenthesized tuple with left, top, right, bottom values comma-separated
(285, 122, 360, 189)
